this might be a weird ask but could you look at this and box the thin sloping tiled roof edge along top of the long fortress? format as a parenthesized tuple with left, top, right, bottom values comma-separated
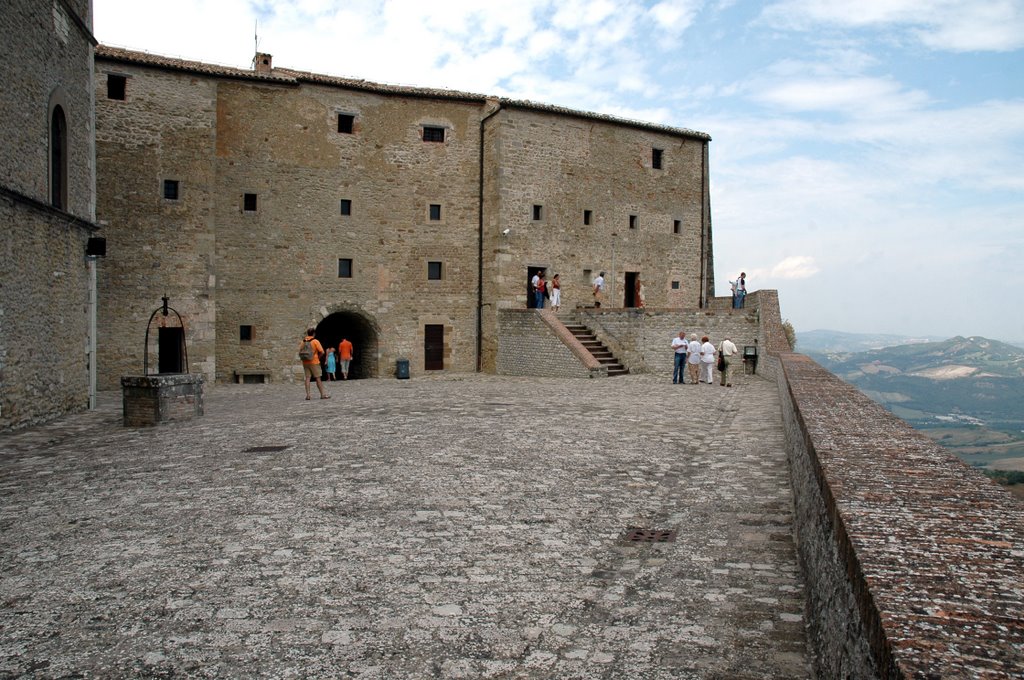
(96, 45, 711, 140)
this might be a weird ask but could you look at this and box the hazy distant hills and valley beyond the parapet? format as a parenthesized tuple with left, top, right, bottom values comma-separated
(797, 332, 1024, 470)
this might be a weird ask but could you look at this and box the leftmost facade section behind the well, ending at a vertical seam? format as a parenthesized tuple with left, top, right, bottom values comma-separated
(95, 63, 218, 389)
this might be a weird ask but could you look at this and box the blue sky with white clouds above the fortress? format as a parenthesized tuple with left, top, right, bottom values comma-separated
(94, 0, 1024, 341)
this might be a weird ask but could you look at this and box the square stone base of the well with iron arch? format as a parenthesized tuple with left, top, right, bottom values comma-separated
(121, 373, 204, 427)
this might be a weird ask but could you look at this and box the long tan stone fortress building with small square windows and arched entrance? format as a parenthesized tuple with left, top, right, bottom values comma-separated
(95, 46, 714, 388)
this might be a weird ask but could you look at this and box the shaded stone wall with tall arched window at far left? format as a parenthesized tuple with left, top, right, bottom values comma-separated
(0, 0, 95, 430)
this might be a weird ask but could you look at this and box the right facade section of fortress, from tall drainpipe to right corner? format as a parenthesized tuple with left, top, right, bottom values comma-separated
(482, 107, 707, 370)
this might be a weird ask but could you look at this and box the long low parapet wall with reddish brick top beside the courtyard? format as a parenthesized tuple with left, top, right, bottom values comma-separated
(766, 352, 1024, 678)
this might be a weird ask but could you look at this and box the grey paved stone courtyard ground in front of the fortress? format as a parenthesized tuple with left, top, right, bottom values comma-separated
(0, 376, 811, 679)
